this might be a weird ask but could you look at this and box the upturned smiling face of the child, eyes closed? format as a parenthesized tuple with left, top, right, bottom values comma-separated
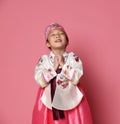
(47, 30, 68, 49)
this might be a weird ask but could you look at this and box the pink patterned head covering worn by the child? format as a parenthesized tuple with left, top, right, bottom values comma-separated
(45, 23, 68, 41)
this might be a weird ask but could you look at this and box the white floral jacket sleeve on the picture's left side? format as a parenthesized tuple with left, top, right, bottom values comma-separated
(35, 55, 57, 87)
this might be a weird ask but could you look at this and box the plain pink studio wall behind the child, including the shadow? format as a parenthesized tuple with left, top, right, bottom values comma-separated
(0, 0, 120, 124)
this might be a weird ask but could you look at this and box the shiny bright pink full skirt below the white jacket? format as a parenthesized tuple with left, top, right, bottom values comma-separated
(32, 87, 92, 124)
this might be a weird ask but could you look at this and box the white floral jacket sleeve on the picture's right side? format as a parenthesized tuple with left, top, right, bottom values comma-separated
(57, 52, 83, 85)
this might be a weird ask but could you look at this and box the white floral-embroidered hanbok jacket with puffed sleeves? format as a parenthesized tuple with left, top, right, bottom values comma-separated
(35, 52, 83, 110)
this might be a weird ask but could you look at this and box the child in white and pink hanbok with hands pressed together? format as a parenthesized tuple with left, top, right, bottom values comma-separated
(32, 23, 92, 124)
